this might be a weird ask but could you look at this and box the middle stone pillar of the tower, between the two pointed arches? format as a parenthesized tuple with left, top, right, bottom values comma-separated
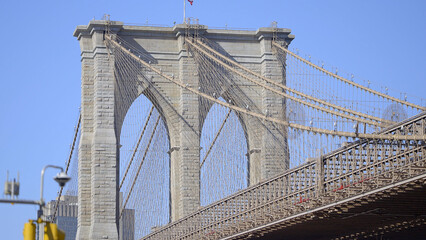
(170, 32, 201, 221)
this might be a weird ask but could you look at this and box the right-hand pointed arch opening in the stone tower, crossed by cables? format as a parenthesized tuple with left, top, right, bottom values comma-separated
(200, 98, 249, 206)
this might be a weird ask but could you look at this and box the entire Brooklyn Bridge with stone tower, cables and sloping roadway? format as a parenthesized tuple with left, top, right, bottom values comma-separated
(51, 19, 426, 239)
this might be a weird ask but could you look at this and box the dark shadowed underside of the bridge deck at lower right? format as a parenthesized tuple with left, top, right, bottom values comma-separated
(230, 175, 426, 240)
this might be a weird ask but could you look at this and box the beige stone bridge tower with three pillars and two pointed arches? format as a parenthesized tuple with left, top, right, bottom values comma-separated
(74, 20, 294, 239)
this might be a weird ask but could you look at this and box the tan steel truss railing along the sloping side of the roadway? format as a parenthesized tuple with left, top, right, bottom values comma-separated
(143, 112, 426, 239)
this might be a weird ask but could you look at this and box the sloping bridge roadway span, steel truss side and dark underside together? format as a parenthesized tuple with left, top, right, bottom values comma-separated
(144, 112, 426, 239)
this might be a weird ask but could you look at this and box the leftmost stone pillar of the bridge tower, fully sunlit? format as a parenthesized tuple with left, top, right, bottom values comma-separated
(73, 21, 120, 239)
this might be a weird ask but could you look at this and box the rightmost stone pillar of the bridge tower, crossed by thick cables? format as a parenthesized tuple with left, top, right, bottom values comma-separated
(247, 28, 291, 185)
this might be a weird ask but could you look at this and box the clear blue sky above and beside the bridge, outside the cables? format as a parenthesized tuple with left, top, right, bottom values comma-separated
(0, 0, 426, 239)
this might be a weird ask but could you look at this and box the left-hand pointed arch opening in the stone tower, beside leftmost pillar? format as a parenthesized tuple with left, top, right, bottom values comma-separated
(119, 94, 170, 239)
